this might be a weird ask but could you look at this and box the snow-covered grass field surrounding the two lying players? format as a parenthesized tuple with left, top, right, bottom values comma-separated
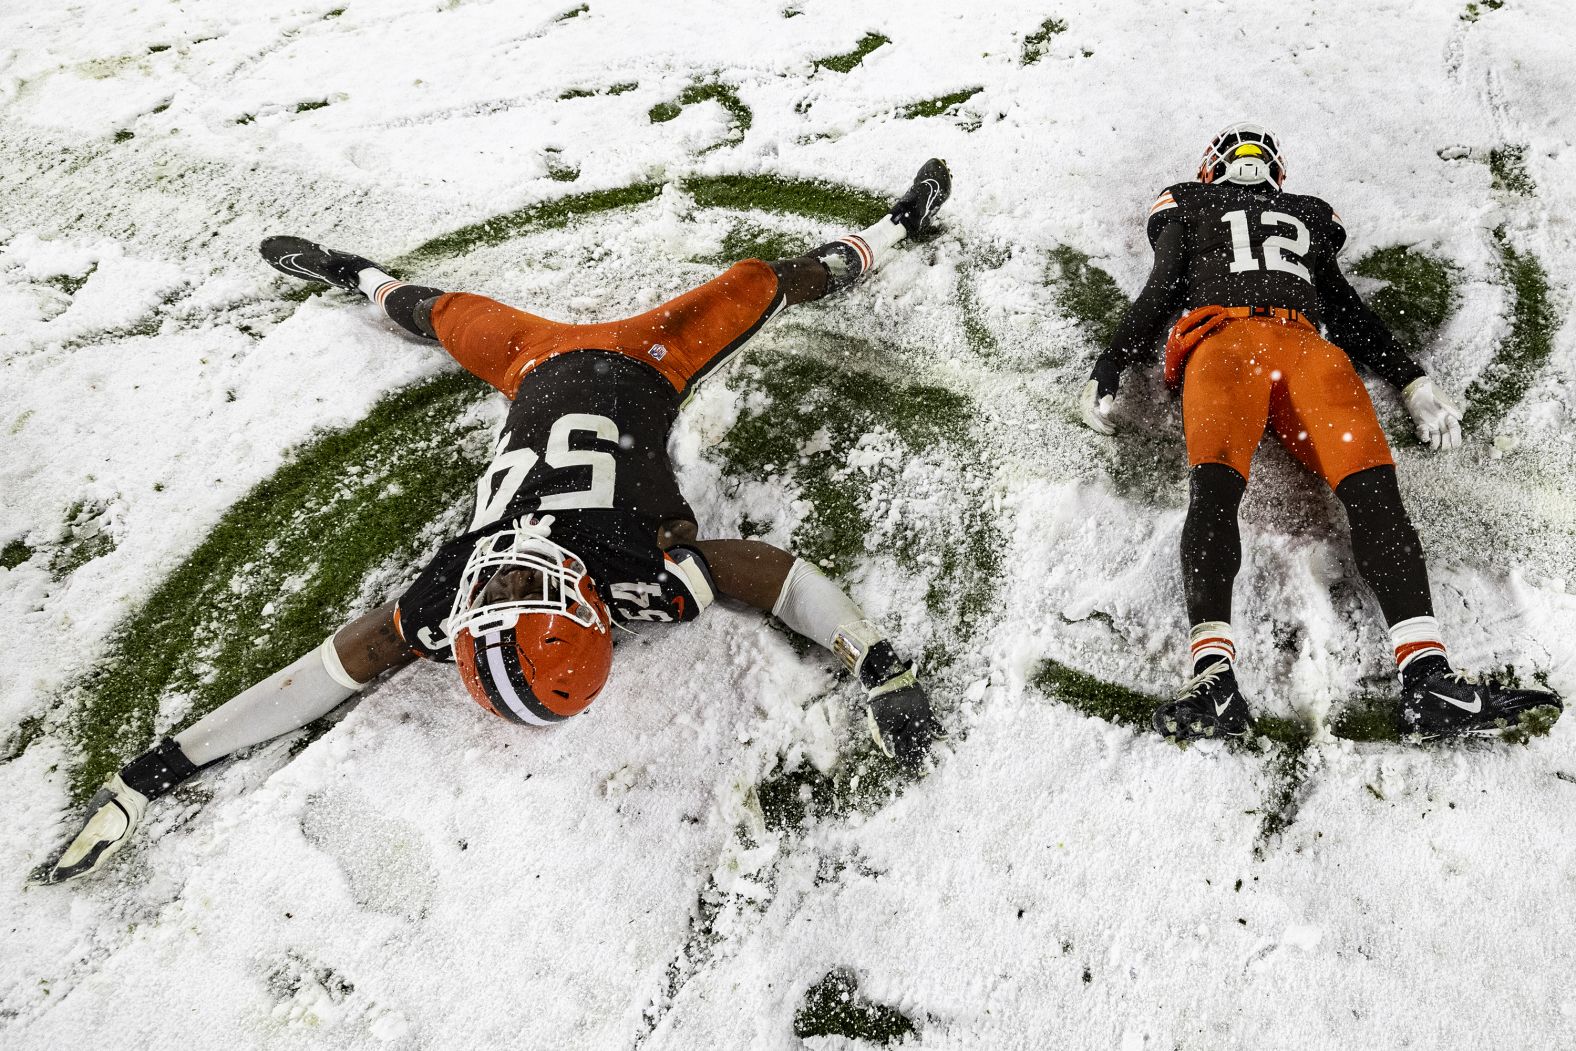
(0, 0, 1576, 1051)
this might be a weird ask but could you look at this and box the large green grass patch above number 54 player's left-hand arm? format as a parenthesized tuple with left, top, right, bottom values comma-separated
(68, 372, 489, 800)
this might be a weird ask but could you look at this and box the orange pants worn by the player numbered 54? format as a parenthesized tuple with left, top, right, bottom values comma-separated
(432, 258, 780, 399)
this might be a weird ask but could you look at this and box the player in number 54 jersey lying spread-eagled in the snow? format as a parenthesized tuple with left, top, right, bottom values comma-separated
(44, 161, 950, 882)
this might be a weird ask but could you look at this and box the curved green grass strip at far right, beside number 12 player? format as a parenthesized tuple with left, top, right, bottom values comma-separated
(1461, 230, 1560, 430)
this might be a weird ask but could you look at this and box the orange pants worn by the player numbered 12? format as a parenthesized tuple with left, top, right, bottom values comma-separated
(1182, 317, 1395, 488)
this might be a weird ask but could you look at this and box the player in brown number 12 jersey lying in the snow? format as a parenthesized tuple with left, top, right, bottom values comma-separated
(1080, 124, 1560, 739)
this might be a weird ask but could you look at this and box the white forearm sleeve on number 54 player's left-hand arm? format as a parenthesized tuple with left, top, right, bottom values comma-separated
(175, 635, 366, 766)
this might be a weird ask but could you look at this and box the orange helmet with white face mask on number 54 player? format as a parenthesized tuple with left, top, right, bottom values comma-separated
(448, 517, 613, 726)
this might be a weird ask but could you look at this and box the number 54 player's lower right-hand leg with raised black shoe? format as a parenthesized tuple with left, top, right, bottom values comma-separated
(772, 158, 952, 306)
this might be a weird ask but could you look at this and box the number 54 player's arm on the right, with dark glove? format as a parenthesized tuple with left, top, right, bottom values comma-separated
(692, 540, 938, 769)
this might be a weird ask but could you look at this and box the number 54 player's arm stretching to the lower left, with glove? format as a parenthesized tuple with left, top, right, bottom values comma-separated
(39, 603, 414, 884)
